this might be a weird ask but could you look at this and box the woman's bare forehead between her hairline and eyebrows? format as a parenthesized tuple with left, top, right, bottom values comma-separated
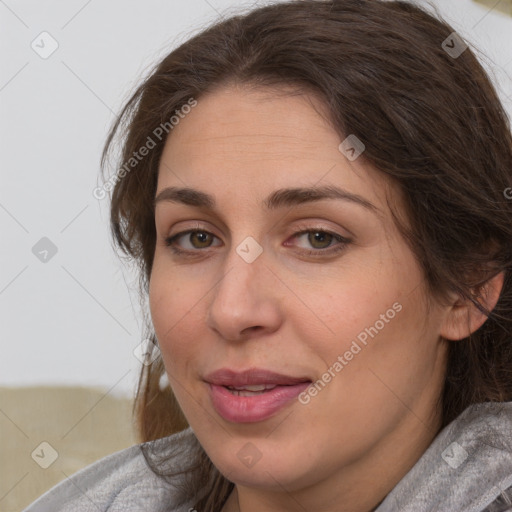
(157, 85, 398, 220)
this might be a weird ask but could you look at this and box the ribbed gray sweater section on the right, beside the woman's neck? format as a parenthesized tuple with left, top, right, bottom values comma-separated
(377, 402, 512, 512)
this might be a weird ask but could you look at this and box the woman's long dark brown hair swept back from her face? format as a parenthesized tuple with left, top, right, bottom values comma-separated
(102, 0, 512, 511)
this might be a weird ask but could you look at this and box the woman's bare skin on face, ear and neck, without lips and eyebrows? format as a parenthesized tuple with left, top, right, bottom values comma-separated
(149, 85, 502, 512)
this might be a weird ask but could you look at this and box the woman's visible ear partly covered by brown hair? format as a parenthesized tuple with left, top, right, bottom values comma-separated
(440, 271, 505, 340)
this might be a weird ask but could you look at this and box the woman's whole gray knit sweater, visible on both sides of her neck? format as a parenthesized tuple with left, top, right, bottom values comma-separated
(23, 402, 512, 512)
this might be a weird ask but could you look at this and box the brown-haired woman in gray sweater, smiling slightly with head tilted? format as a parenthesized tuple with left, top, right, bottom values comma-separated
(26, 0, 512, 512)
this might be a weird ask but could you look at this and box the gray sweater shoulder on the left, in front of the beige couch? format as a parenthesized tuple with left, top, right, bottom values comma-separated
(23, 427, 195, 512)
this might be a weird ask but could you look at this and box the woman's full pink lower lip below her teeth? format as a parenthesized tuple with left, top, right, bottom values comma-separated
(209, 382, 311, 423)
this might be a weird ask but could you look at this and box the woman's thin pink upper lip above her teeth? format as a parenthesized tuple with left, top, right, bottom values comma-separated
(204, 368, 311, 386)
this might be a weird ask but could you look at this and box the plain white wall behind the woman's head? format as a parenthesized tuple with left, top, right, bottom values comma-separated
(0, 0, 512, 395)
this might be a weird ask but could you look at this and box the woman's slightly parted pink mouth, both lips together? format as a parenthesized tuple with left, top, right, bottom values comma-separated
(205, 368, 311, 423)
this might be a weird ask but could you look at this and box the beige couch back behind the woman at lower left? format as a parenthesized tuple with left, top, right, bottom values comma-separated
(0, 387, 137, 512)
